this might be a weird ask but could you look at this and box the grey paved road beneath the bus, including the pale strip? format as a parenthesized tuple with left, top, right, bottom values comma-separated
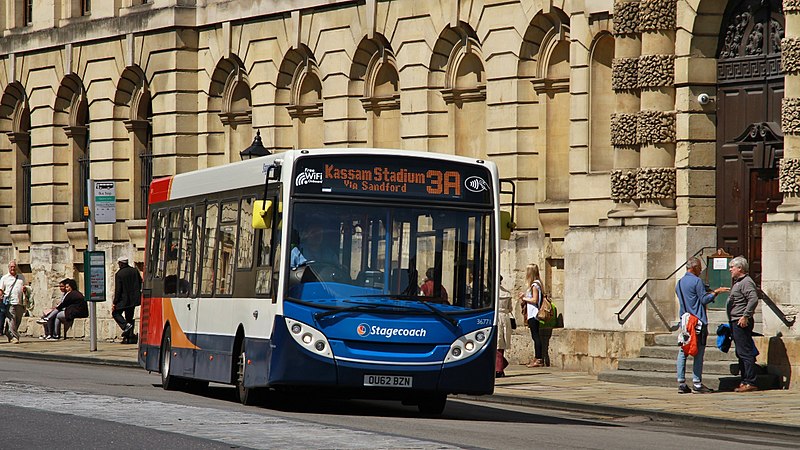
(0, 358, 796, 449)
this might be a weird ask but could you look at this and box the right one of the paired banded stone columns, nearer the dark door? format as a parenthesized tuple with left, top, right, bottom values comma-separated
(635, 0, 677, 223)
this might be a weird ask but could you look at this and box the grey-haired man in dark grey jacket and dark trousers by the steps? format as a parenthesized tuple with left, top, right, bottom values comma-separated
(727, 256, 758, 392)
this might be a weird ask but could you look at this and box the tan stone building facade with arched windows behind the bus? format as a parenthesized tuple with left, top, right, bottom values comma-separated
(0, 0, 800, 386)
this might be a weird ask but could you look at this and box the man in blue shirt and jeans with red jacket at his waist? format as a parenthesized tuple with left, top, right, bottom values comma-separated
(675, 257, 728, 394)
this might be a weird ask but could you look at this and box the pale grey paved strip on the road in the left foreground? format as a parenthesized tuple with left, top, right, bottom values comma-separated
(0, 383, 457, 449)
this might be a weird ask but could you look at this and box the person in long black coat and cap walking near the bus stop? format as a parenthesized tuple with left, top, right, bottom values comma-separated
(111, 256, 142, 344)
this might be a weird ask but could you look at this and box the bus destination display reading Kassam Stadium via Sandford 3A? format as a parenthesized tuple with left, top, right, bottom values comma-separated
(294, 156, 491, 203)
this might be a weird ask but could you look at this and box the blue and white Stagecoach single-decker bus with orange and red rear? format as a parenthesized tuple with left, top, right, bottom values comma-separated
(139, 149, 506, 414)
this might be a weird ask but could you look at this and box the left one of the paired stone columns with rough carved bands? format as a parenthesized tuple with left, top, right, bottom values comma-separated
(608, 1, 642, 218)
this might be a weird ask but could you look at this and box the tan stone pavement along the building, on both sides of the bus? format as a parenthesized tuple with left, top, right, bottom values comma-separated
(0, 338, 800, 435)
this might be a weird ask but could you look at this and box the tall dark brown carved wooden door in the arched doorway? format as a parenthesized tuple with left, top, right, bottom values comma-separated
(716, 0, 784, 282)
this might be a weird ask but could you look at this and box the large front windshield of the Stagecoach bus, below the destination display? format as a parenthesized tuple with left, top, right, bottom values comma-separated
(286, 201, 494, 312)
